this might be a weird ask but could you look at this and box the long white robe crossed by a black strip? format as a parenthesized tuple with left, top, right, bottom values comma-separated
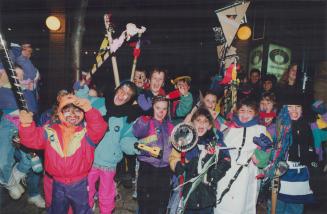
(214, 125, 266, 214)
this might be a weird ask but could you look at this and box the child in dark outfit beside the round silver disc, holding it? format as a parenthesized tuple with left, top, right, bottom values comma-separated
(169, 108, 230, 214)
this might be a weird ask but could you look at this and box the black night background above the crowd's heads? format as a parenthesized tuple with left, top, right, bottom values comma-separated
(0, 0, 327, 110)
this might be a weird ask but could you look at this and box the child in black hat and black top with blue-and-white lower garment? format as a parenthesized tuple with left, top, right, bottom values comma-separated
(268, 94, 320, 214)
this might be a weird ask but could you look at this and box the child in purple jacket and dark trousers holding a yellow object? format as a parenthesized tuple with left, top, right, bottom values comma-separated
(133, 96, 173, 214)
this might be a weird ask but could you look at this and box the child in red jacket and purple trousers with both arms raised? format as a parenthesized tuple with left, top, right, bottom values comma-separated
(19, 95, 108, 214)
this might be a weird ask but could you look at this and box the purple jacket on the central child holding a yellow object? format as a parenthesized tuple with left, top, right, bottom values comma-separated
(133, 116, 174, 168)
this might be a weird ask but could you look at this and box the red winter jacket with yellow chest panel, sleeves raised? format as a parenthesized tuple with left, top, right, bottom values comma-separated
(19, 108, 108, 183)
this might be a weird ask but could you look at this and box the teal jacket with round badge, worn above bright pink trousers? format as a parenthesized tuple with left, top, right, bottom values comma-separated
(93, 117, 138, 170)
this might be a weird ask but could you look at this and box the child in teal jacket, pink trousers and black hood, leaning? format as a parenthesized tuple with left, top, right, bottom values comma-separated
(88, 81, 137, 213)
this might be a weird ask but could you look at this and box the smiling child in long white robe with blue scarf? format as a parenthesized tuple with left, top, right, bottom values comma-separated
(214, 98, 272, 214)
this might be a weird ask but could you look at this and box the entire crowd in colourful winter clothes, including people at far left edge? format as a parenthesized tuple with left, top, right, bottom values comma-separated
(0, 43, 327, 214)
